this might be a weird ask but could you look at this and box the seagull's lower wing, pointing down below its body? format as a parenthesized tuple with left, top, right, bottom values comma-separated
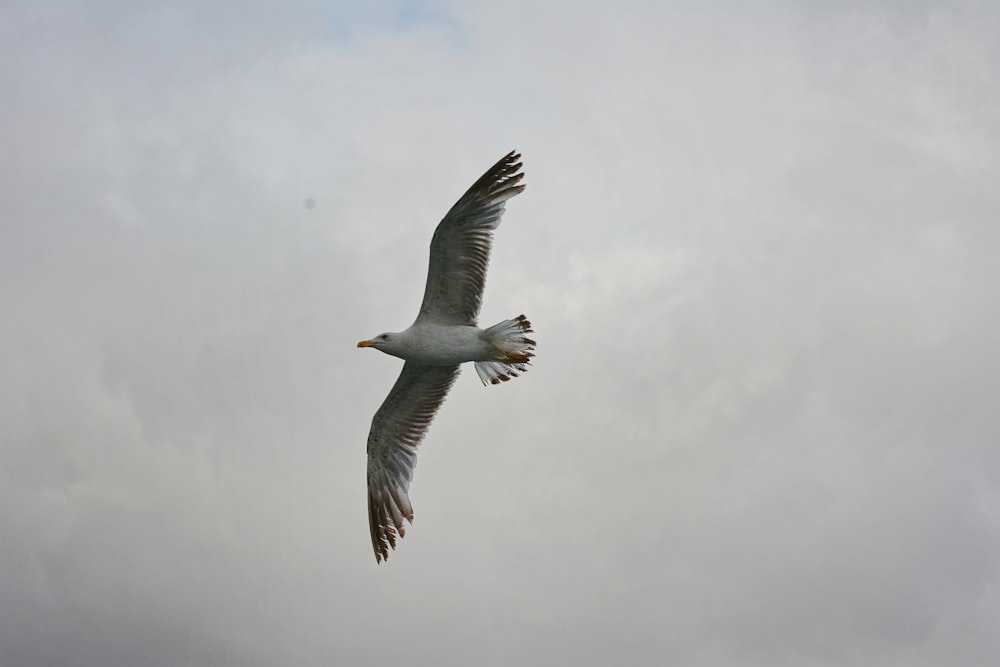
(368, 361, 459, 562)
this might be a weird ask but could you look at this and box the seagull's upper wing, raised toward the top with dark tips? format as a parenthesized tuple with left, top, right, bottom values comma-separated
(417, 151, 524, 325)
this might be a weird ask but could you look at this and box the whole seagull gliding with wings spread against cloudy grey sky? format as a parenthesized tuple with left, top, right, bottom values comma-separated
(358, 151, 536, 563)
